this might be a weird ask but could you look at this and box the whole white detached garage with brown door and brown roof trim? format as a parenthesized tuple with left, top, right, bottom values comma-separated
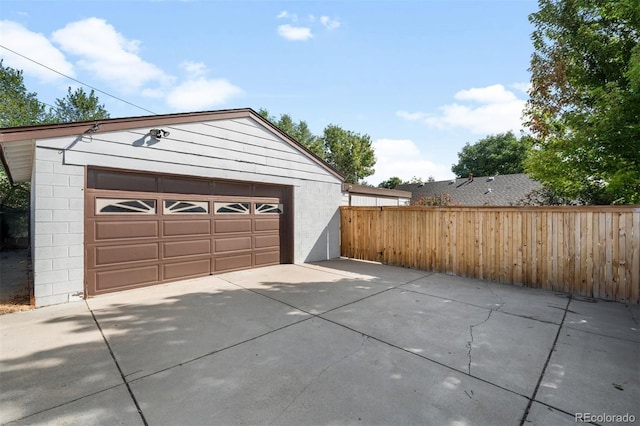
(0, 109, 344, 306)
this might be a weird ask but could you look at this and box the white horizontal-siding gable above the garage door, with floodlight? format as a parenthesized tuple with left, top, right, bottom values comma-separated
(37, 118, 339, 184)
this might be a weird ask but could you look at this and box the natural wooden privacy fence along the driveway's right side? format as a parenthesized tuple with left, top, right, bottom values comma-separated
(340, 206, 640, 303)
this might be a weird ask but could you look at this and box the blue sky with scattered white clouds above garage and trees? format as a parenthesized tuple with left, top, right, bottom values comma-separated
(0, 0, 537, 185)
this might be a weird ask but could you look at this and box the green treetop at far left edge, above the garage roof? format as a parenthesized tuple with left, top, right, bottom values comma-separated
(0, 60, 45, 128)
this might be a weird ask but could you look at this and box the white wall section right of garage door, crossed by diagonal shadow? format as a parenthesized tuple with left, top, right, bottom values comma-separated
(294, 181, 342, 263)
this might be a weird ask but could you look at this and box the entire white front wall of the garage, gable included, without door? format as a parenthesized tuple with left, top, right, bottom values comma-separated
(32, 118, 342, 306)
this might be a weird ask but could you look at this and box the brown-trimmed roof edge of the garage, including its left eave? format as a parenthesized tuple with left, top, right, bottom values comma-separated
(0, 108, 344, 182)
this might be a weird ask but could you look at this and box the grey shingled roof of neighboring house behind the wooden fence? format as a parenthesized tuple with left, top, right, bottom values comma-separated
(396, 173, 542, 206)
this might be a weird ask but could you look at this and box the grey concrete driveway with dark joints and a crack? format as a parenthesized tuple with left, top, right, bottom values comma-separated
(0, 260, 640, 425)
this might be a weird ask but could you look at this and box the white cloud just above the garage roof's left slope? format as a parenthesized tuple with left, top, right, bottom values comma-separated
(166, 77, 242, 111)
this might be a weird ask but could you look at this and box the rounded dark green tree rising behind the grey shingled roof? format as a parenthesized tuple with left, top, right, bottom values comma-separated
(451, 132, 531, 178)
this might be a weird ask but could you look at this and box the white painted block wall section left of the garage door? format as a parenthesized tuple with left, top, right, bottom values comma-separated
(31, 147, 84, 306)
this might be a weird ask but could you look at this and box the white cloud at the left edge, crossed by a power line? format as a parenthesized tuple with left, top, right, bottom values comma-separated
(0, 21, 75, 82)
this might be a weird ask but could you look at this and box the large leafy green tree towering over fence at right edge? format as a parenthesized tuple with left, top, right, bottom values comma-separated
(525, 0, 640, 204)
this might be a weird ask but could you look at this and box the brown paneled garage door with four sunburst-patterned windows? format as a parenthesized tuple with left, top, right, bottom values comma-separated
(85, 189, 284, 295)
